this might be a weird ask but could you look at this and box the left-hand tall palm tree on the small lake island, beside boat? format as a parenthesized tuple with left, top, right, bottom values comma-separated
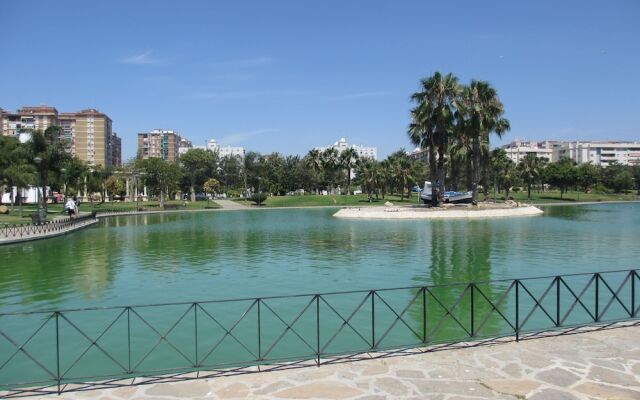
(411, 72, 460, 203)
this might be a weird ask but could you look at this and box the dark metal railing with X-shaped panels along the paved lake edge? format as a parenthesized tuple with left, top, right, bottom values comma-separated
(0, 270, 640, 397)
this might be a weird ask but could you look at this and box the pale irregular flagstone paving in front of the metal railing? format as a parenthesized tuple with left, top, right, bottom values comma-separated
(28, 325, 640, 400)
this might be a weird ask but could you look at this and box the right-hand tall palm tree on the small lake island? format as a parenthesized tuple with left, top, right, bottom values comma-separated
(457, 79, 510, 205)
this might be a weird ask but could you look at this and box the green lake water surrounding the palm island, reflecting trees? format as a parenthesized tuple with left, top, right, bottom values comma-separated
(0, 203, 640, 386)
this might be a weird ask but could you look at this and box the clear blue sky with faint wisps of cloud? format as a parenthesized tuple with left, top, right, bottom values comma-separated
(0, 0, 640, 159)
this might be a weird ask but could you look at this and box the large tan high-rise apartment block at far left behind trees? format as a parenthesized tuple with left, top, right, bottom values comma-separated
(0, 105, 122, 166)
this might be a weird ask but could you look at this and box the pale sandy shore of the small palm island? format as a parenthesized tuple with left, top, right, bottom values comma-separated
(333, 205, 543, 219)
